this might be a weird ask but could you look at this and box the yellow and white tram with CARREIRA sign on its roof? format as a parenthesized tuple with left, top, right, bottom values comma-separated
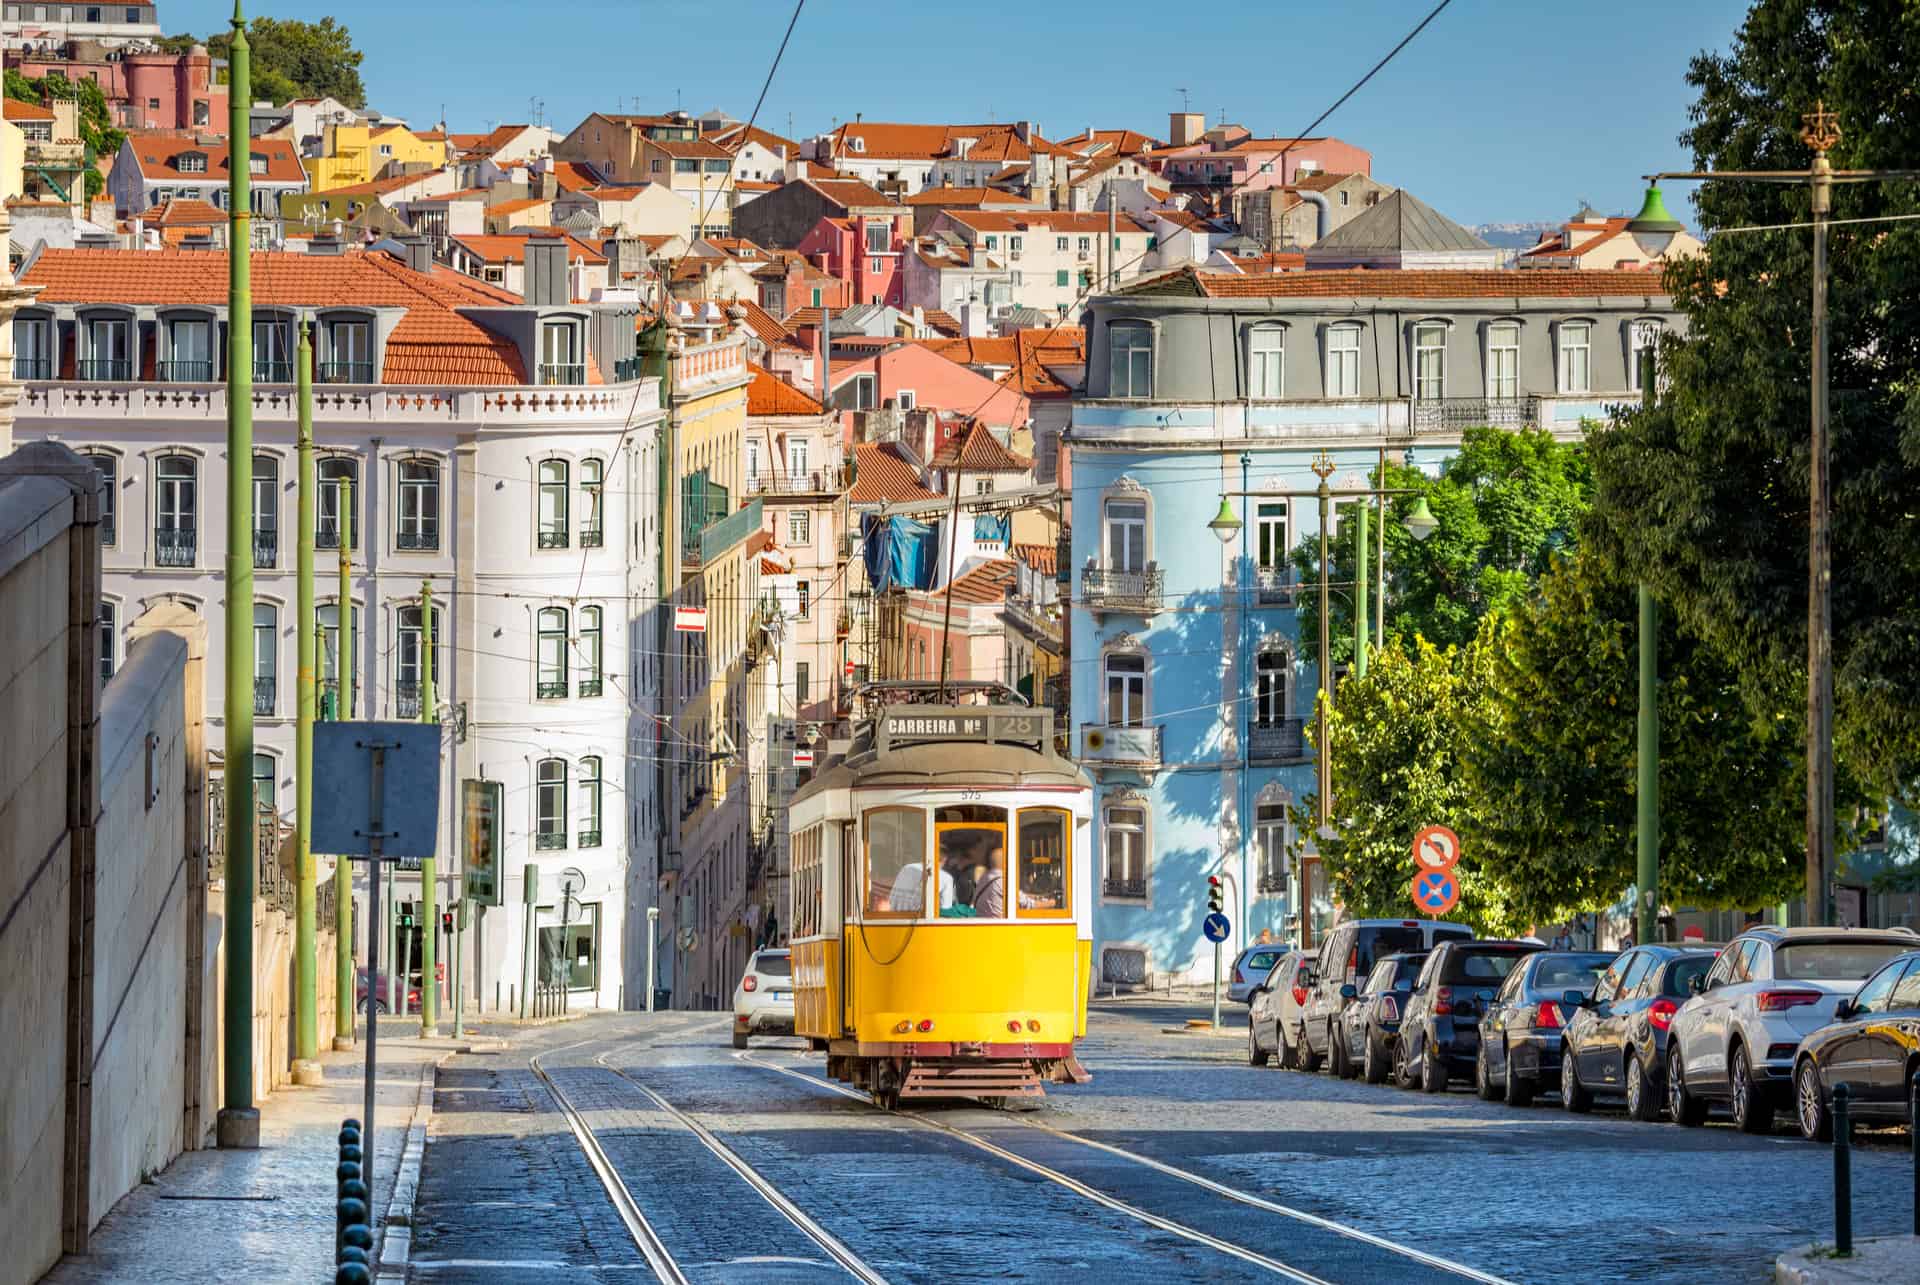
(787, 684, 1092, 1108)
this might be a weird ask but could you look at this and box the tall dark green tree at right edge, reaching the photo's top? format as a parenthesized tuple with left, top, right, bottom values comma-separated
(1582, 0, 1920, 799)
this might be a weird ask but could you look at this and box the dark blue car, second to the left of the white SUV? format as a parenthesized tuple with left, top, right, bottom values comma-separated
(1473, 951, 1613, 1106)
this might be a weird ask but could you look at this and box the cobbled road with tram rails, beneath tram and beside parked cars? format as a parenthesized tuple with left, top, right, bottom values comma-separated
(413, 1003, 1910, 1283)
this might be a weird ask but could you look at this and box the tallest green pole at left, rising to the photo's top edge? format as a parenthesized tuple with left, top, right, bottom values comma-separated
(215, 0, 259, 1147)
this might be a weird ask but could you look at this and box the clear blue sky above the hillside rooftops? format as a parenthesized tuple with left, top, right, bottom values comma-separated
(180, 0, 1747, 223)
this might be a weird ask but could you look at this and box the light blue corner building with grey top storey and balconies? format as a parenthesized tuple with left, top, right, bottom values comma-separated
(1064, 269, 1676, 983)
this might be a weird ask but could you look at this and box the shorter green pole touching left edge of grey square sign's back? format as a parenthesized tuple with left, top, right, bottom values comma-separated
(294, 317, 321, 1085)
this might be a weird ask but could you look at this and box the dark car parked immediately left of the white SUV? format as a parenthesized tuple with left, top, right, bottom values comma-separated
(1561, 945, 1720, 1120)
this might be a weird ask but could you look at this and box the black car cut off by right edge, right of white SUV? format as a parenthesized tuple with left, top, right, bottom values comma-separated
(1793, 951, 1920, 1143)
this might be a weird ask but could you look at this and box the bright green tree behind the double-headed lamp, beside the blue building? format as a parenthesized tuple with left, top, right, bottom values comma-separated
(1292, 428, 1590, 665)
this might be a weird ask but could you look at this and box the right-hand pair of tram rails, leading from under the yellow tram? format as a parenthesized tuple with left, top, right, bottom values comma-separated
(733, 1053, 1513, 1285)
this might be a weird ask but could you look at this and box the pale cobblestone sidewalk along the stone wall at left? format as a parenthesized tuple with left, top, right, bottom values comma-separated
(42, 1022, 453, 1285)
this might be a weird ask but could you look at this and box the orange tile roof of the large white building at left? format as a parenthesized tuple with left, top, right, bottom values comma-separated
(21, 250, 526, 384)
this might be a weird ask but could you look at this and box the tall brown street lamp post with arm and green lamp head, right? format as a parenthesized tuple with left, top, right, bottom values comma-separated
(1626, 102, 1920, 924)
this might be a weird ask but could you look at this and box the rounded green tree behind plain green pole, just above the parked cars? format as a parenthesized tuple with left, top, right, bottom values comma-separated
(1459, 553, 1820, 922)
